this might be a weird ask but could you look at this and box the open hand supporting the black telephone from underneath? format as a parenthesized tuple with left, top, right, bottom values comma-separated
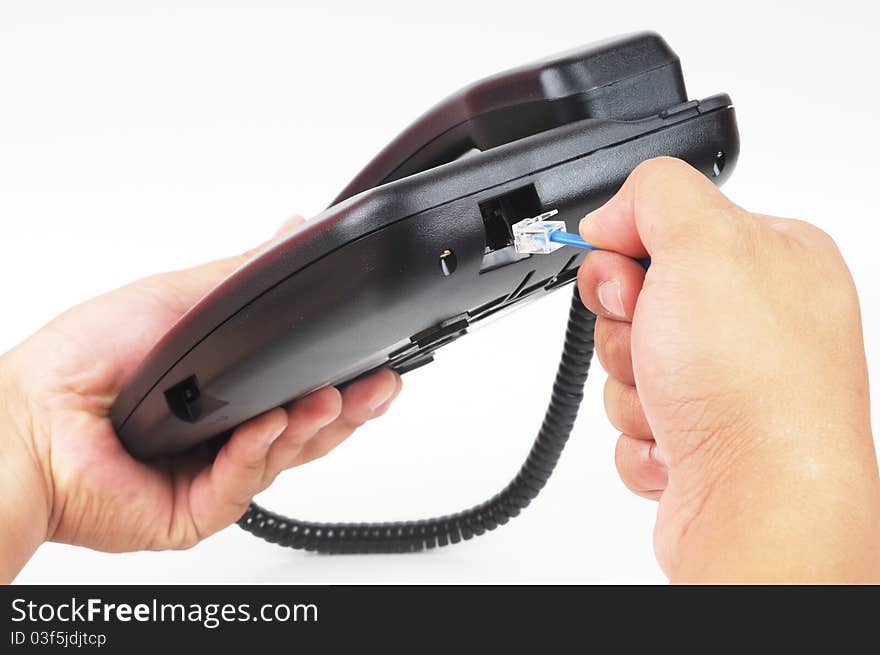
(0, 218, 401, 582)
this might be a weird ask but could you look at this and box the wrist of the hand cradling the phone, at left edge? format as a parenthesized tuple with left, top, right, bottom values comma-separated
(0, 353, 52, 583)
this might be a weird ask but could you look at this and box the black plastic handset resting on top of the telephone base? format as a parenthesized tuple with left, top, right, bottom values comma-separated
(333, 33, 687, 204)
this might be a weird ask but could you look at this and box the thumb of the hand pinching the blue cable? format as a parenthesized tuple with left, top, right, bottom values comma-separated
(580, 157, 738, 260)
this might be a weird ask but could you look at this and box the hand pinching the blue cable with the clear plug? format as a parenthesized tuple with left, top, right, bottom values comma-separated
(578, 158, 880, 583)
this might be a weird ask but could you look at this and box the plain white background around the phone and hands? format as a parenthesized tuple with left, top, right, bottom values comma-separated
(0, 0, 880, 583)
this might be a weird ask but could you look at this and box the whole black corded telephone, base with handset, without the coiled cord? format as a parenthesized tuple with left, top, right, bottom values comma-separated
(111, 33, 739, 458)
